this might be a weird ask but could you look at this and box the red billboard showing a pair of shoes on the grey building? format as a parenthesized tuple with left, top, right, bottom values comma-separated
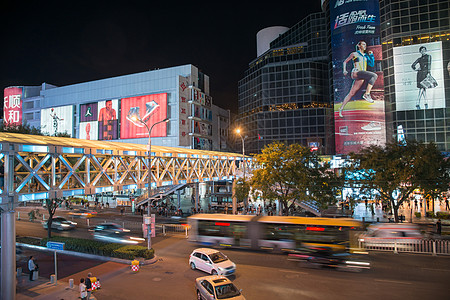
(120, 93, 167, 139)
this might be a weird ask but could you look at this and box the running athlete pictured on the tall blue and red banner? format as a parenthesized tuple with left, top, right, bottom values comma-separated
(339, 41, 378, 118)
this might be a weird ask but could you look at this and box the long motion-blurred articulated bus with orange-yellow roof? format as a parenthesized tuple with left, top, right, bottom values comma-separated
(188, 214, 362, 252)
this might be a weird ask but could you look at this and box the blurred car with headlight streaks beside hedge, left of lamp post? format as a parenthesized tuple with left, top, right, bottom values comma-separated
(91, 223, 145, 245)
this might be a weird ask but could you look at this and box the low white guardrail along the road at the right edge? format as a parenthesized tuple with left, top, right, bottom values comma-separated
(359, 239, 450, 255)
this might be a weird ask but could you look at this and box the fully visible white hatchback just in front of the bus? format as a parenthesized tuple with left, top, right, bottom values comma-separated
(189, 248, 236, 276)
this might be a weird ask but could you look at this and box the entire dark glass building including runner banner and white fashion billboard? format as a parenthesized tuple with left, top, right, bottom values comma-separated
(238, 0, 450, 154)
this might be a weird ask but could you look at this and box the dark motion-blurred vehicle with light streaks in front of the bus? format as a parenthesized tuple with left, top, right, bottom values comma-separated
(288, 246, 370, 272)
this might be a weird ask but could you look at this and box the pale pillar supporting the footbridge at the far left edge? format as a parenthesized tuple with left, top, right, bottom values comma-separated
(1, 210, 16, 300)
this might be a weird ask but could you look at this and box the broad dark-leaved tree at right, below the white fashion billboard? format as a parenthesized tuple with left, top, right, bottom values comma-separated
(345, 141, 450, 222)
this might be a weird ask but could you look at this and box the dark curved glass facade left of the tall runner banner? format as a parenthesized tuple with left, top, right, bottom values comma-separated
(237, 13, 334, 154)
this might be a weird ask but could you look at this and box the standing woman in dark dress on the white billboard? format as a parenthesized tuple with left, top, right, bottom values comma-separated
(411, 46, 437, 109)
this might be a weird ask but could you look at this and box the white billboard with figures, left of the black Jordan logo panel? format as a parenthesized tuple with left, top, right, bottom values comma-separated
(41, 105, 73, 136)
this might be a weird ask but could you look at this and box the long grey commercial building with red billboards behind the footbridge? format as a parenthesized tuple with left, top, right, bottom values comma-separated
(4, 65, 230, 151)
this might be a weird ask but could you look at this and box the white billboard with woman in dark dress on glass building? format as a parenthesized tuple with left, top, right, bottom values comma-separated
(393, 41, 445, 110)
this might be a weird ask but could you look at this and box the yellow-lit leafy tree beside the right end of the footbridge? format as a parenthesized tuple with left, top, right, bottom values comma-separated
(251, 142, 339, 214)
